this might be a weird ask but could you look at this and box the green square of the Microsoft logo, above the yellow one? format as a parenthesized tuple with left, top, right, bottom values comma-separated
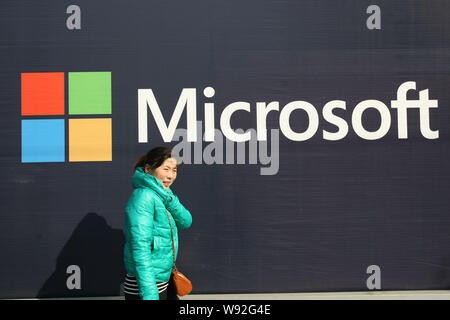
(68, 72, 111, 114)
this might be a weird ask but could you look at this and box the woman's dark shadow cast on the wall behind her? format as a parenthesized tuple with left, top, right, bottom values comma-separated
(37, 212, 125, 298)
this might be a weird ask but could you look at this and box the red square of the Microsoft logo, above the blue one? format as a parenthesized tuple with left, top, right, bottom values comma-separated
(21, 72, 64, 116)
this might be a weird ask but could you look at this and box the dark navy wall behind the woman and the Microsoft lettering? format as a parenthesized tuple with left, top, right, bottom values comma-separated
(0, 0, 450, 298)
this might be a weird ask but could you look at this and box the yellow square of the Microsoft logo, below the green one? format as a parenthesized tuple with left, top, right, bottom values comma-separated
(69, 118, 112, 162)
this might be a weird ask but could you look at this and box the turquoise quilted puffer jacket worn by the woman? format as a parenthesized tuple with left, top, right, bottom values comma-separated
(124, 168, 192, 300)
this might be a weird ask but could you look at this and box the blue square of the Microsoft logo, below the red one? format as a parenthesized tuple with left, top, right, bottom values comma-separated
(22, 119, 65, 162)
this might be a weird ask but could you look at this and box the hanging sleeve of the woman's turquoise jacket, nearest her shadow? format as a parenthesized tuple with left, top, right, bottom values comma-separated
(126, 189, 159, 300)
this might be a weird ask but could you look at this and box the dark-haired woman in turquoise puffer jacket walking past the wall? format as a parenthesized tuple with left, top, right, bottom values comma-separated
(124, 147, 192, 300)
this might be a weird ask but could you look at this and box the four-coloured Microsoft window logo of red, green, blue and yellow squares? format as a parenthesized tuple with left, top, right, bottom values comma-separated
(21, 72, 112, 163)
